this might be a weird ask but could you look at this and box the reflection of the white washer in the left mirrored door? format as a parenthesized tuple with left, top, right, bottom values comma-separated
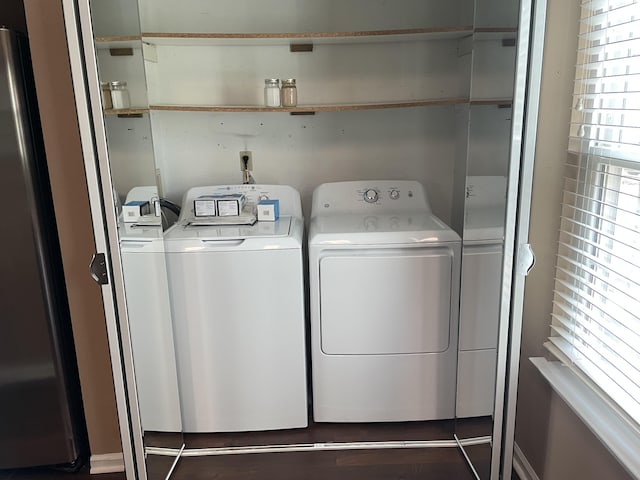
(118, 186, 182, 432)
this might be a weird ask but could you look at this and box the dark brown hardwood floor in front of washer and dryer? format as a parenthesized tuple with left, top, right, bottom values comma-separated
(0, 418, 491, 480)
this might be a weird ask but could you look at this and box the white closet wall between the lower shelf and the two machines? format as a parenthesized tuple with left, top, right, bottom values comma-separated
(152, 107, 456, 221)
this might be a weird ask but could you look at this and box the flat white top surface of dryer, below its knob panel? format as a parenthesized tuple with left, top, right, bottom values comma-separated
(309, 212, 460, 245)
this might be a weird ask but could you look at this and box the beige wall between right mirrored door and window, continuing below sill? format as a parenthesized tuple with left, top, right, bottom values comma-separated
(516, 0, 630, 480)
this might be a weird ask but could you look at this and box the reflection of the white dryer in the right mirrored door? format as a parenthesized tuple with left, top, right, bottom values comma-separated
(456, 176, 507, 417)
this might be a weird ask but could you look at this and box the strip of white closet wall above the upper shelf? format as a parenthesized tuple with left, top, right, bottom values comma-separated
(138, 0, 472, 33)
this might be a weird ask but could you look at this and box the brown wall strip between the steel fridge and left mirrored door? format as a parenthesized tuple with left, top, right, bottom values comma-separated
(21, 0, 122, 455)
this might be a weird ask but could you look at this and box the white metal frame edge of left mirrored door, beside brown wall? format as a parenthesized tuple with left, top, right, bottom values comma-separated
(62, 0, 147, 480)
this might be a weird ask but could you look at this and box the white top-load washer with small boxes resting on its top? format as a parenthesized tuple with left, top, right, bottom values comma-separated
(165, 185, 308, 432)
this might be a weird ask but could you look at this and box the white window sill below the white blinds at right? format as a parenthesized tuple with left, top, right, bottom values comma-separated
(529, 357, 640, 478)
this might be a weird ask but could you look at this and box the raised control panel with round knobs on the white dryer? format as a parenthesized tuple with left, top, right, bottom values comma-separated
(312, 180, 430, 214)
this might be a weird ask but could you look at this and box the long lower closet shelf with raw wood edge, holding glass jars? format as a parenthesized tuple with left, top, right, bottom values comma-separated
(149, 98, 469, 114)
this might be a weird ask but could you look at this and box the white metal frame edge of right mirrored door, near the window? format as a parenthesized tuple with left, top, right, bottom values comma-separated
(491, 0, 547, 480)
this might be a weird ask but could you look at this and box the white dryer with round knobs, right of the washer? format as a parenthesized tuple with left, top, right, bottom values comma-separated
(309, 181, 460, 422)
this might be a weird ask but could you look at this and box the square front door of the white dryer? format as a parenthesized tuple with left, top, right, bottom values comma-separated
(320, 246, 455, 355)
